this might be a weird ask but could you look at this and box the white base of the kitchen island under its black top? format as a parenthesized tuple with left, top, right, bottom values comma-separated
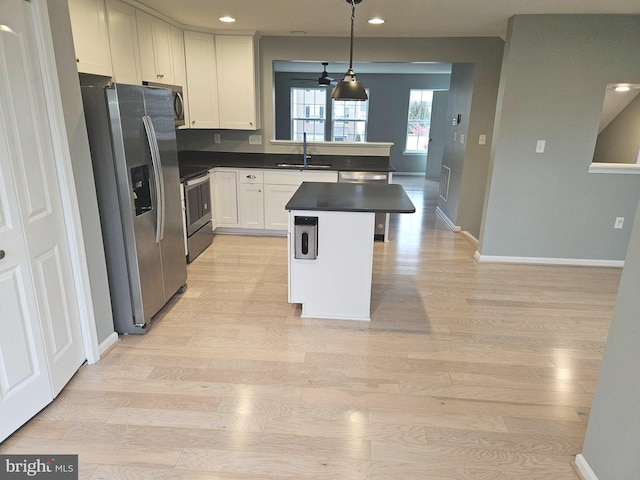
(288, 210, 375, 321)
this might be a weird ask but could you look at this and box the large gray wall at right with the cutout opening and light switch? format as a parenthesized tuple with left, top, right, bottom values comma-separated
(478, 15, 640, 261)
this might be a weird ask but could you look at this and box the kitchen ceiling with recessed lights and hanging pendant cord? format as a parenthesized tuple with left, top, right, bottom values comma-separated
(132, 0, 640, 38)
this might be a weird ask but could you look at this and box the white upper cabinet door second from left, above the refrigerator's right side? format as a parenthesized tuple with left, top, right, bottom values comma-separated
(107, 0, 142, 85)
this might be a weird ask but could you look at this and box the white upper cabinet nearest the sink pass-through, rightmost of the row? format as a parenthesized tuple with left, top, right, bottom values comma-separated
(216, 35, 259, 130)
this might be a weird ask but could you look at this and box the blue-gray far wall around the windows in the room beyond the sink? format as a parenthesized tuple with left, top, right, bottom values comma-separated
(274, 72, 450, 174)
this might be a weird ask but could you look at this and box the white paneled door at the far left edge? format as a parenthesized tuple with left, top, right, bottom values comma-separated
(0, 0, 85, 440)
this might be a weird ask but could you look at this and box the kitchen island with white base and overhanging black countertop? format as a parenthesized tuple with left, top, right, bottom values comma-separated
(285, 182, 415, 321)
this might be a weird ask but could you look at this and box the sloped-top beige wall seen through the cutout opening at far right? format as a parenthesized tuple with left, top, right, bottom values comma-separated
(593, 95, 640, 163)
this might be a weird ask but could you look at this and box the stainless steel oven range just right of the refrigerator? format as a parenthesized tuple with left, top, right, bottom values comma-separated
(183, 173, 213, 263)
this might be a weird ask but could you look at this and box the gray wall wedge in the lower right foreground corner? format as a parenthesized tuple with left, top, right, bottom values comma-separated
(582, 194, 640, 480)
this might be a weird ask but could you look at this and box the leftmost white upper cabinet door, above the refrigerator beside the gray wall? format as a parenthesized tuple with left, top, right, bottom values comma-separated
(69, 0, 113, 77)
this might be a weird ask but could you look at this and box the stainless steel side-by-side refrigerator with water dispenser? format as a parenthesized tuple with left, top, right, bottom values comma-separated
(82, 84, 187, 334)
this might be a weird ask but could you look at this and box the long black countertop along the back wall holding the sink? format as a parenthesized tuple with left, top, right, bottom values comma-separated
(178, 150, 395, 180)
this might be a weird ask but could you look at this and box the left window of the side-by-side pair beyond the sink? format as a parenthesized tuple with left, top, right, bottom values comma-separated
(291, 88, 327, 141)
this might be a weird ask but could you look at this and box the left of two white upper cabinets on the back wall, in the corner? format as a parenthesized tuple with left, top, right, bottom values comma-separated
(184, 31, 220, 128)
